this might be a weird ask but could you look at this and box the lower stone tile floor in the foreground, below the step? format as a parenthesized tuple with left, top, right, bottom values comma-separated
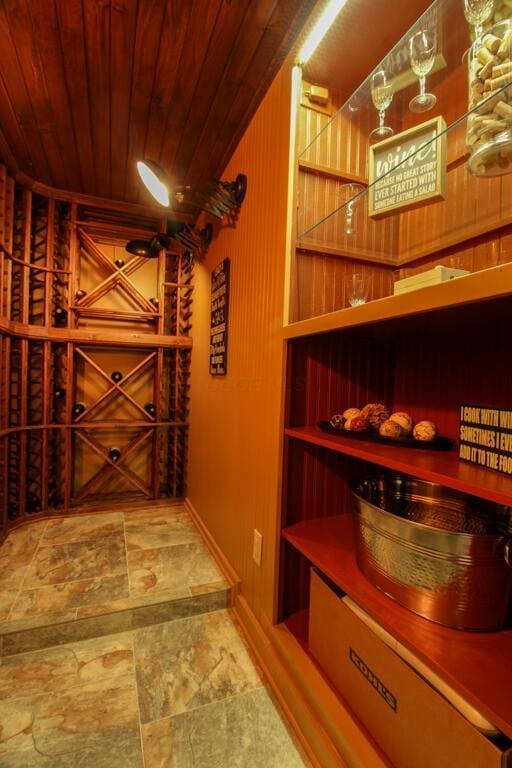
(0, 610, 306, 768)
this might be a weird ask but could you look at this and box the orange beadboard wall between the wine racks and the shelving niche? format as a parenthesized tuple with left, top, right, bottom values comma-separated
(188, 65, 291, 619)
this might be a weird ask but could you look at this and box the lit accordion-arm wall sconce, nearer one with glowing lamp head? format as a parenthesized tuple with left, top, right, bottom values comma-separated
(137, 160, 247, 219)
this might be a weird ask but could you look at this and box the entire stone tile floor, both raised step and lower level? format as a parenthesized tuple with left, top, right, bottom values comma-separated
(0, 506, 306, 768)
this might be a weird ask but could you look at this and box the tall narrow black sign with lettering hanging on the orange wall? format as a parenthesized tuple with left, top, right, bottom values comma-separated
(210, 259, 229, 376)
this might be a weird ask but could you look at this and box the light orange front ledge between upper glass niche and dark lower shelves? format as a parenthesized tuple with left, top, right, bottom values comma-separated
(282, 263, 512, 339)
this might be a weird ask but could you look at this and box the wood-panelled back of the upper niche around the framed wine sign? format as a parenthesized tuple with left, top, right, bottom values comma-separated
(290, 0, 512, 322)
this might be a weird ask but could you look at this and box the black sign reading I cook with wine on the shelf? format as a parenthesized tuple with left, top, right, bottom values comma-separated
(459, 405, 512, 475)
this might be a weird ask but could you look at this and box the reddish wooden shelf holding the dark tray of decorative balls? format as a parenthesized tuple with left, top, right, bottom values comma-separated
(284, 427, 512, 506)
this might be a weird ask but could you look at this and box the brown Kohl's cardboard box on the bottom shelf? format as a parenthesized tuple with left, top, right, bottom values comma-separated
(309, 571, 512, 768)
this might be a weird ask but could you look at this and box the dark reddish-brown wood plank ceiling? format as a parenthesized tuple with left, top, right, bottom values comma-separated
(0, 0, 316, 203)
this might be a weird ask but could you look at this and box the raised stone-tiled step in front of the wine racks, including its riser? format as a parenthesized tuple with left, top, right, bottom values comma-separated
(0, 505, 230, 656)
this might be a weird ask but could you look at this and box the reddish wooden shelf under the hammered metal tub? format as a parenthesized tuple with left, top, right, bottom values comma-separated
(283, 515, 512, 738)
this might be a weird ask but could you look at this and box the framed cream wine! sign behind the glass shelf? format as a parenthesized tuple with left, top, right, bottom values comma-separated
(368, 117, 446, 216)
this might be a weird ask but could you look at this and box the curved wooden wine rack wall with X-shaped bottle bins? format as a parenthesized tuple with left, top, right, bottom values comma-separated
(0, 167, 193, 535)
